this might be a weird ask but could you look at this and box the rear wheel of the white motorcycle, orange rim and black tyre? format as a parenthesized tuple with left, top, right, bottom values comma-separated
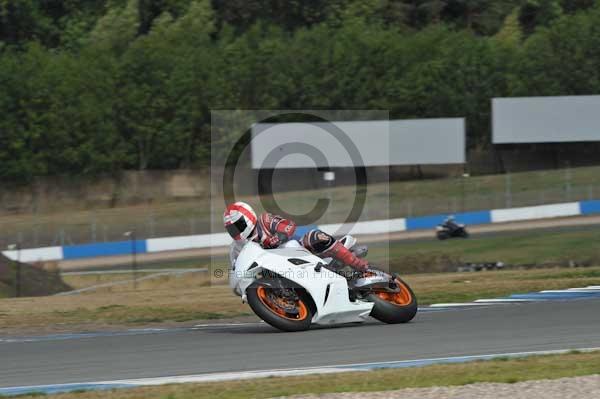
(368, 277, 418, 324)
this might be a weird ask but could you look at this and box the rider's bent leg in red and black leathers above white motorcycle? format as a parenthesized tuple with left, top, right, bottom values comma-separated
(302, 229, 369, 271)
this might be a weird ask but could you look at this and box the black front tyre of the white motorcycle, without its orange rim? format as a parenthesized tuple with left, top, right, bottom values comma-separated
(246, 279, 314, 332)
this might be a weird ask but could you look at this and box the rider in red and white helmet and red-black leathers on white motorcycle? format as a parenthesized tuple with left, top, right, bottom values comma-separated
(223, 202, 369, 271)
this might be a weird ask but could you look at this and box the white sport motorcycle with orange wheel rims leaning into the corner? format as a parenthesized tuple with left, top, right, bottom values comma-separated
(229, 236, 417, 331)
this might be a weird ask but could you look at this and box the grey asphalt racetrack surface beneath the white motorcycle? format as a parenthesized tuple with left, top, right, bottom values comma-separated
(0, 299, 600, 387)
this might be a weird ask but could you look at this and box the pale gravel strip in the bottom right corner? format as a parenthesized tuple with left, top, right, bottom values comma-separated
(287, 375, 600, 399)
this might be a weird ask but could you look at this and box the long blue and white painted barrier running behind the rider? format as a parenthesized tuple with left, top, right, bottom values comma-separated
(2, 200, 600, 263)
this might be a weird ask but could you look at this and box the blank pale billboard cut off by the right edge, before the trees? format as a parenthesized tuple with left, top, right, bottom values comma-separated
(492, 96, 600, 144)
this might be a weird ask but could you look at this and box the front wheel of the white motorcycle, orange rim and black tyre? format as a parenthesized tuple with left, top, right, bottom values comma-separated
(246, 279, 314, 332)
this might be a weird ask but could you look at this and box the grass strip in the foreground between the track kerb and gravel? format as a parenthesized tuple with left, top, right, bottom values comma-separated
(8, 352, 600, 399)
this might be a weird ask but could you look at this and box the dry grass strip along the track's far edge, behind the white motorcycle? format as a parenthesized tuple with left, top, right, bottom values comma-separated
(0, 267, 600, 335)
